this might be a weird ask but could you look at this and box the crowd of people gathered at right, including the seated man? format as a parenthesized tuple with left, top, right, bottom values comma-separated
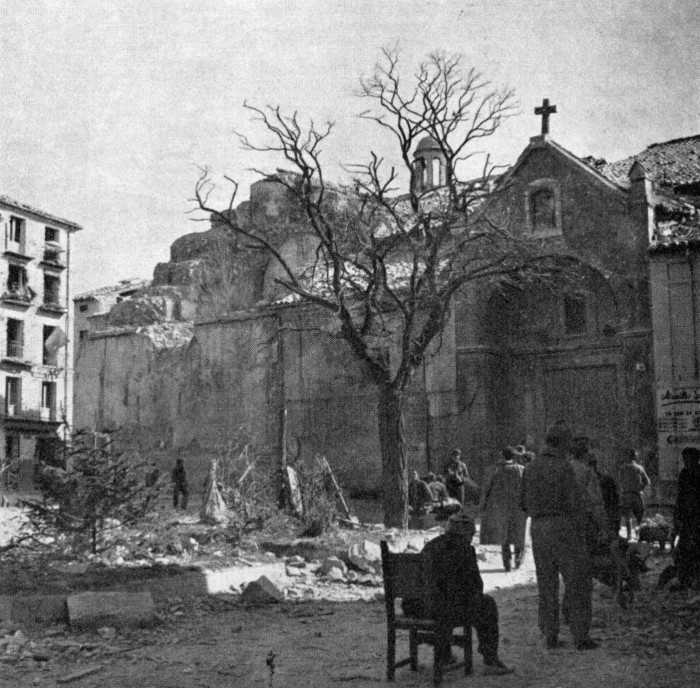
(409, 423, 672, 674)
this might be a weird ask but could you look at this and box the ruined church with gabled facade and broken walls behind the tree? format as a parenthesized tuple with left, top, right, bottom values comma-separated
(75, 129, 700, 500)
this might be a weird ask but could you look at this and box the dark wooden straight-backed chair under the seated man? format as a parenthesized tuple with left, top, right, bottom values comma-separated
(380, 540, 472, 686)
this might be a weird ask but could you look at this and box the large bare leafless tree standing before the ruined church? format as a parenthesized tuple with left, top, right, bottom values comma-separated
(196, 49, 568, 527)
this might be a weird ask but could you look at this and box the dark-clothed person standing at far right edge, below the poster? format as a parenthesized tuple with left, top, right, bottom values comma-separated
(673, 447, 700, 589)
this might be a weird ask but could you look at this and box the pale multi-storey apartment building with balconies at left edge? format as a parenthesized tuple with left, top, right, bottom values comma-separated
(0, 196, 82, 491)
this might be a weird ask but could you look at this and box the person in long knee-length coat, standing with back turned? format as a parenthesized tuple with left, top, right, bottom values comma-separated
(479, 447, 527, 571)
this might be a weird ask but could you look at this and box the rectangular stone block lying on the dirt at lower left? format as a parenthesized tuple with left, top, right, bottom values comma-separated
(67, 592, 156, 630)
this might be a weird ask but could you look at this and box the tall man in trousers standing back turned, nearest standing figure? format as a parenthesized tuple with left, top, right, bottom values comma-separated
(520, 423, 598, 650)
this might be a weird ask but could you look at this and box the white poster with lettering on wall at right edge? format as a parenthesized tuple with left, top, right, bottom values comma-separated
(657, 387, 700, 480)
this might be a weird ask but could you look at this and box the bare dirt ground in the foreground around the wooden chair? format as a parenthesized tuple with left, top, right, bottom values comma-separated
(0, 500, 700, 688)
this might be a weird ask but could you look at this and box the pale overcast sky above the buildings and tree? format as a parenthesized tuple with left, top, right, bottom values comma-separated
(0, 0, 700, 293)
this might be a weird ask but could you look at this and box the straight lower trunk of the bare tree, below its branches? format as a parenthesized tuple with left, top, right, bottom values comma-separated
(378, 385, 408, 528)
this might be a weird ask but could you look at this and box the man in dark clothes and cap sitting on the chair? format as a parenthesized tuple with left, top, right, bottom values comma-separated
(423, 513, 513, 676)
